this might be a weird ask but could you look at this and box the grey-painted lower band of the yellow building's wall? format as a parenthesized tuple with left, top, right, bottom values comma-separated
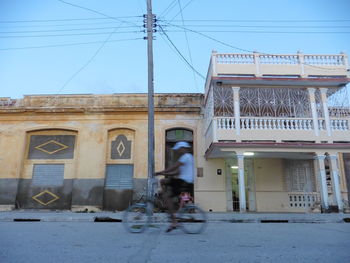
(0, 178, 147, 212)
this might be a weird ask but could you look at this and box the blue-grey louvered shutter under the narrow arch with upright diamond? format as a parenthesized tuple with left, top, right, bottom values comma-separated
(105, 164, 134, 189)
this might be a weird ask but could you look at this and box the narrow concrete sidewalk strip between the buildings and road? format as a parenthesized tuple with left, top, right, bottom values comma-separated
(0, 210, 350, 223)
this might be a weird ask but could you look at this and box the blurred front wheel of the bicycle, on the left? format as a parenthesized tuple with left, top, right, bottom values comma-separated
(123, 204, 149, 233)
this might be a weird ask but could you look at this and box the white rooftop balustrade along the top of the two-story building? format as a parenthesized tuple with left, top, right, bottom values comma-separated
(205, 52, 349, 82)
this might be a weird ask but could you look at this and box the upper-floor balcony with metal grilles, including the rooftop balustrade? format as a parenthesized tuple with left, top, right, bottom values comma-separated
(204, 52, 350, 152)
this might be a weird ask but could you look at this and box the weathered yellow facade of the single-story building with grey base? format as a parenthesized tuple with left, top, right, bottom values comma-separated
(0, 94, 201, 210)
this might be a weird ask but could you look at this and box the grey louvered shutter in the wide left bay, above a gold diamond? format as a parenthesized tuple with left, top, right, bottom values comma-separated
(32, 164, 64, 186)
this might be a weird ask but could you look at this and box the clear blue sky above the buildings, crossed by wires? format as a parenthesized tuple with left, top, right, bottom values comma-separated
(0, 0, 350, 98)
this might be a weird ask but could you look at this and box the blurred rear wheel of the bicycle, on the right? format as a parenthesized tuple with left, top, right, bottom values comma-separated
(178, 205, 207, 234)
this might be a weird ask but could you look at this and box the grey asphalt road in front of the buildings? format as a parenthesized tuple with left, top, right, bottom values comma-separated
(0, 222, 350, 263)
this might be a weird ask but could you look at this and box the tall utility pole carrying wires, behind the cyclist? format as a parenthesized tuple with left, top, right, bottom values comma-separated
(146, 0, 154, 198)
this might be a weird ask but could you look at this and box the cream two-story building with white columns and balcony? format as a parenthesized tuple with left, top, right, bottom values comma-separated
(197, 52, 350, 212)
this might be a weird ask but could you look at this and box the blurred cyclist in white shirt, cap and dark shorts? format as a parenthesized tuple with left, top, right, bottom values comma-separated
(156, 141, 194, 232)
